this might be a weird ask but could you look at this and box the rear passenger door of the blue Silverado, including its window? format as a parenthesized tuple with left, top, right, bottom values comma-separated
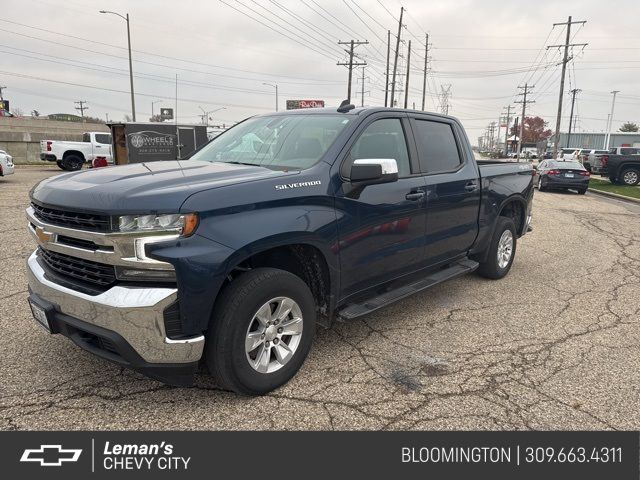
(411, 115, 480, 265)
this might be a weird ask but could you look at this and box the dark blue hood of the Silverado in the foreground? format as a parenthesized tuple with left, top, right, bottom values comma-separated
(31, 160, 298, 214)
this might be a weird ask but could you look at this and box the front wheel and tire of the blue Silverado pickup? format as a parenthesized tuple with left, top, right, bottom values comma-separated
(205, 268, 316, 395)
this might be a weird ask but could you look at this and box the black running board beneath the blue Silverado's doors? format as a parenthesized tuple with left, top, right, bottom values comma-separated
(338, 258, 479, 320)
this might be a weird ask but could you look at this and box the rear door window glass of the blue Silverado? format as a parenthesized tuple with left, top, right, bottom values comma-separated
(415, 119, 462, 173)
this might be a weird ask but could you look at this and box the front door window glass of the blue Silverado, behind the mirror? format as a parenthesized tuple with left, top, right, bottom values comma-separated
(348, 118, 411, 177)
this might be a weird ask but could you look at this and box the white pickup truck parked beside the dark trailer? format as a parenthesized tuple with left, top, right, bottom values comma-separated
(40, 132, 112, 170)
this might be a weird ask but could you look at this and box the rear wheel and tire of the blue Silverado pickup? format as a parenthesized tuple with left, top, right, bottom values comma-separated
(478, 217, 517, 280)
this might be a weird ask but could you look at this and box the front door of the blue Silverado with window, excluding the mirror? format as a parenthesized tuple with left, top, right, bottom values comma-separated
(334, 113, 426, 298)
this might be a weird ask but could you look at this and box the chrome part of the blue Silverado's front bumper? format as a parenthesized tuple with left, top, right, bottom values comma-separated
(27, 252, 204, 363)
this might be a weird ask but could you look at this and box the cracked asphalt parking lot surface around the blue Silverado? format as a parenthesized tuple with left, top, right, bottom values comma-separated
(0, 167, 640, 430)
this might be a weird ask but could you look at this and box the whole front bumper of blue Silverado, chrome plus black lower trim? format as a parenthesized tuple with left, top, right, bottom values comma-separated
(27, 252, 204, 383)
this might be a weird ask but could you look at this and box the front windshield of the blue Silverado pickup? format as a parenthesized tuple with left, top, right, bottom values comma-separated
(191, 114, 350, 170)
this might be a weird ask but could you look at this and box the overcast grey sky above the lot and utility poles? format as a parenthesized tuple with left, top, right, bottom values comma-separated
(0, 0, 640, 144)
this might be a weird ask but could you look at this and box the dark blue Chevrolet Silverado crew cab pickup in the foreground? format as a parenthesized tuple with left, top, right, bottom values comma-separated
(26, 104, 533, 395)
